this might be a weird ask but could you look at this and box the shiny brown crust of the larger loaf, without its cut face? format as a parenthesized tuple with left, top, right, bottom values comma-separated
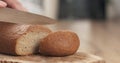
(0, 22, 51, 55)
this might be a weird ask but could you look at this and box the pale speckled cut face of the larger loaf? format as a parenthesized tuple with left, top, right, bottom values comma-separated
(16, 32, 48, 55)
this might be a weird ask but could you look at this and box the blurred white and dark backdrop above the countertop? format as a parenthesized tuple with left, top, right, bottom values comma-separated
(19, 0, 120, 20)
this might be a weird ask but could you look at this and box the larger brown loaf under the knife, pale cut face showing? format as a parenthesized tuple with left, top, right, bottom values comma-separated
(0, 22, 51, 55)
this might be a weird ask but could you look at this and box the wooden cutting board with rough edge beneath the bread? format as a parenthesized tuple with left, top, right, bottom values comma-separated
(0, 52, 105, 63)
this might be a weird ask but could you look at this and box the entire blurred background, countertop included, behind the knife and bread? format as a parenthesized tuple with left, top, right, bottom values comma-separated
(19, 0, 120, 63)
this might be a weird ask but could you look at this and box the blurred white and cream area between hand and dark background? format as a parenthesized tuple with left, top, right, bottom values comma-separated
(19, 0, 58, 19)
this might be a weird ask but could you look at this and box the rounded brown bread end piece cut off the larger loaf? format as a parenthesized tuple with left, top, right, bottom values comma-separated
(39, 31, 80, 56)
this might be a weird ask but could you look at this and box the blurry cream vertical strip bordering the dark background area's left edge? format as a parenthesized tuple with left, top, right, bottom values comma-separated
(44, 0, 59, 19)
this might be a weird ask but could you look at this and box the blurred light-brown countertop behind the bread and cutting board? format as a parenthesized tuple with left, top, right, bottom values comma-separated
(47, 20, 120, 63)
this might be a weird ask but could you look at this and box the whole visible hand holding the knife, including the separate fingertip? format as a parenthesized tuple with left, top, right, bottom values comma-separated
(0, 0, 27, 11)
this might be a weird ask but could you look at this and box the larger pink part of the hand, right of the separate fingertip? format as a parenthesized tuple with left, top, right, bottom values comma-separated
(4, 0, 27, 11)
